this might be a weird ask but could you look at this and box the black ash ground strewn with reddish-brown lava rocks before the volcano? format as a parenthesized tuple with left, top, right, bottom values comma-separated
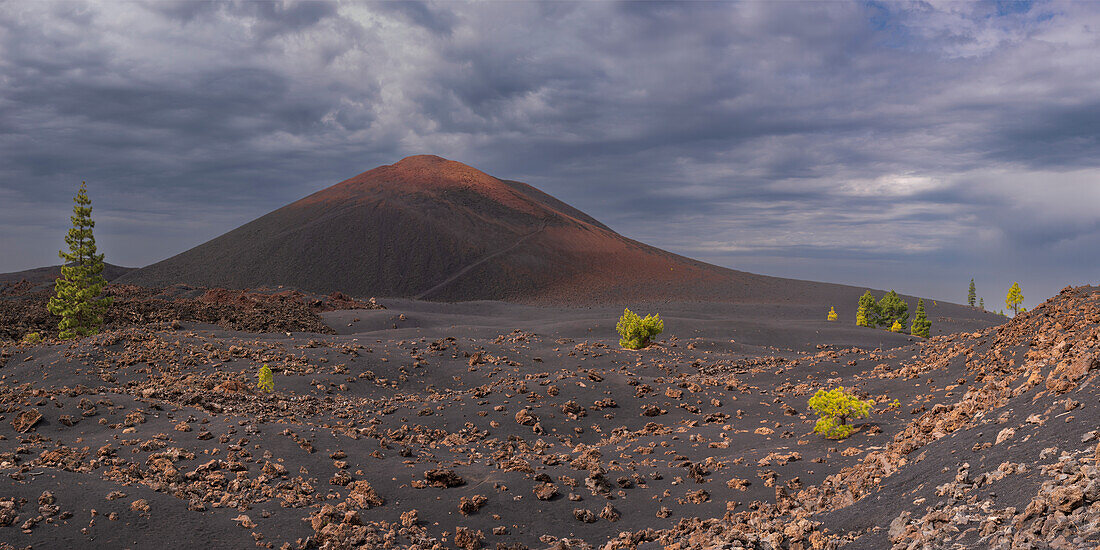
(0, 288, 1100, 549)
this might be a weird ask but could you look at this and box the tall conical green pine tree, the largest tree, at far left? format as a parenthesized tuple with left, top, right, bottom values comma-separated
(50, 182, 111, 339)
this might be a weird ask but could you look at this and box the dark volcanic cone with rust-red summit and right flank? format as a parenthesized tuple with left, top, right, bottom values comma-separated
(120, 155, 998, 318)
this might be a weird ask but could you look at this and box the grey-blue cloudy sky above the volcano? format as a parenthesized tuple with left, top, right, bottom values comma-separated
(0, 0, 1100, 308)
